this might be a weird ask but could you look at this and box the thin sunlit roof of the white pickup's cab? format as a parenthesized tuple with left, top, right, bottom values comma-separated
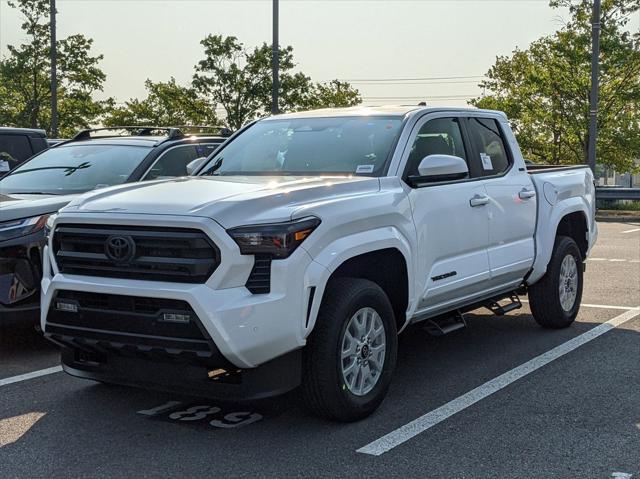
(268, 105, 504, 120)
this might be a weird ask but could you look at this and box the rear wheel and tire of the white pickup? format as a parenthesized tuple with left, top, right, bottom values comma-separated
(529, 236, 583, 329)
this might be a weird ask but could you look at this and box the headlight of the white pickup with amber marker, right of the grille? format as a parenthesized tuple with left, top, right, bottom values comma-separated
(227, 216, 320, 259)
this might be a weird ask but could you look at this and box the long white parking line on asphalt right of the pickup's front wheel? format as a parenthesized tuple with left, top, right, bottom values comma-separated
(357, 307, 640, 456)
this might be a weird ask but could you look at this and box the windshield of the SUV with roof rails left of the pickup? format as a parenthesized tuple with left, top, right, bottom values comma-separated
(0, 143, 151, 195)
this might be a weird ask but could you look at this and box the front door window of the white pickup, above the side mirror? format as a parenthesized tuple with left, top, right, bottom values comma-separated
(405, 118, 467, 176)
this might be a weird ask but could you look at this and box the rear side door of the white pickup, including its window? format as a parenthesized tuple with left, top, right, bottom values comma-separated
(466, 116, 537, 286)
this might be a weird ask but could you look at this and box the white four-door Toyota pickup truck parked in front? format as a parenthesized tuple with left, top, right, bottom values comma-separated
(41, 107, 597, 421)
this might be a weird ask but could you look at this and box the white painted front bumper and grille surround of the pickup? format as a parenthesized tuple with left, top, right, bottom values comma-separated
(41, 213, 327, 369)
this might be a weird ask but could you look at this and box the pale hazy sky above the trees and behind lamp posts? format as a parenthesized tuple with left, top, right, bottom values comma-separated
(0, 0, 640, 106)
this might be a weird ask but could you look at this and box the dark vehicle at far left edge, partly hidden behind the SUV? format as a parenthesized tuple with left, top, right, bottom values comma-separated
(0, 127, 49, 173)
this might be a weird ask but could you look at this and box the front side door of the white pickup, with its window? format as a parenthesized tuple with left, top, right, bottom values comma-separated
(402, 115, 490, 314)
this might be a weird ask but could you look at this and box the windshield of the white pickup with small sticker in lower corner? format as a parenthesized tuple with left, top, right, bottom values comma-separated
(200, 116, 402, 176)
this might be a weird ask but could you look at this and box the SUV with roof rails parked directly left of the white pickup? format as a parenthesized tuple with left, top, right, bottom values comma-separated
(0, 127, 230, 321)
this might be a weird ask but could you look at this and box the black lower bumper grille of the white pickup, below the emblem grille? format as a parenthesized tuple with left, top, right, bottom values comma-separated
(45, 290, 220, 362)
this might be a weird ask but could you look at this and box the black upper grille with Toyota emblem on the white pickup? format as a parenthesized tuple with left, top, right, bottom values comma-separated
(53, 224, 220, 283)
